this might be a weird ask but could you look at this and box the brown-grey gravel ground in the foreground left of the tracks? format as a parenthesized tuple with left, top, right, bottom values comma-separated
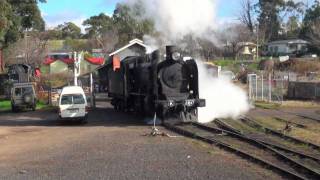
(0, 102, 282, 180)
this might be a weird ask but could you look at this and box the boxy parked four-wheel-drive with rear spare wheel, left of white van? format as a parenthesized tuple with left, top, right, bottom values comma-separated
(11, 83, 37, 112)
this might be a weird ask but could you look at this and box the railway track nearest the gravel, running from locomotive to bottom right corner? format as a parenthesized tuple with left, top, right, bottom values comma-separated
(165, 123, 320, 179)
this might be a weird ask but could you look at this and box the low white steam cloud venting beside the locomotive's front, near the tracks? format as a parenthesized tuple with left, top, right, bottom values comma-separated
(197, 62, 250, 123)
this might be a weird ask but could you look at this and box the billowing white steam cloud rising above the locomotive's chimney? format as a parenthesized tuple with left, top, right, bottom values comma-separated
(125, 0, 216, 42)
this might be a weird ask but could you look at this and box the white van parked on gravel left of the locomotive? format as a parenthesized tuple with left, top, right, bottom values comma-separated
(59, 86, 89, 123)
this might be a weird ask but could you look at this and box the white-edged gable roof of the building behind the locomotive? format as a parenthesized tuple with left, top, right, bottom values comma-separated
(109, 39, 147, 61)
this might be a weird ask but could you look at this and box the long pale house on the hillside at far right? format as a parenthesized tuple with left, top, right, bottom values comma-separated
(267, 39, 309, 56)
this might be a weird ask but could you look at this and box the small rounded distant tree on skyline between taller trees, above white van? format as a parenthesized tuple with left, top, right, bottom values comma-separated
(55, 22, 81, 39)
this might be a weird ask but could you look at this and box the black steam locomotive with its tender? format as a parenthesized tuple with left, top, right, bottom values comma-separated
(107, 46, 205, 122)
